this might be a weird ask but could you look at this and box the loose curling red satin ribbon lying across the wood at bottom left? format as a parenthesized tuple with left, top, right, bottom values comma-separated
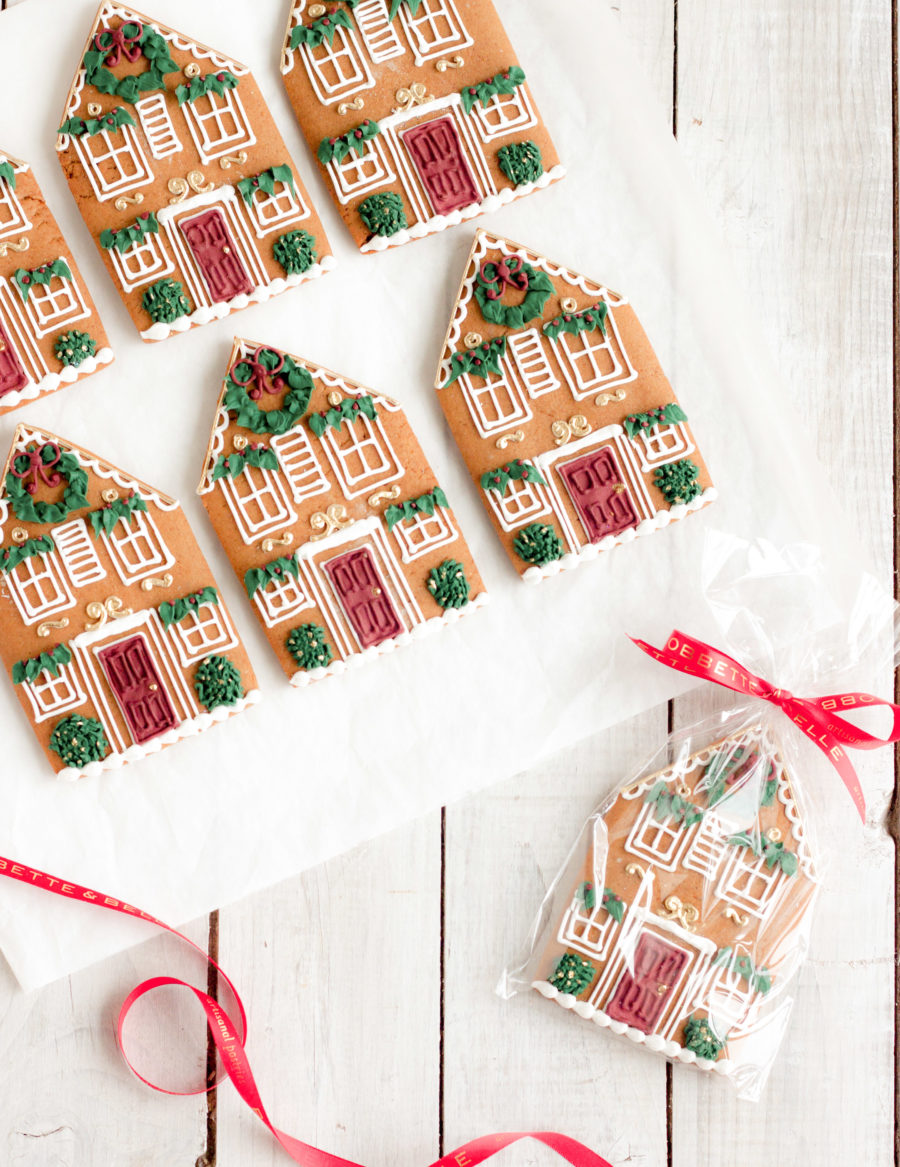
(0, 857, 611, 1167)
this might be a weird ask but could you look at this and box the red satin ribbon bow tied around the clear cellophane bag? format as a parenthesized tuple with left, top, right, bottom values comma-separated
(632, 631, 900, 823)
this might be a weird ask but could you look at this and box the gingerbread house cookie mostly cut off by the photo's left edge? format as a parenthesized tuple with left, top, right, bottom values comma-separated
(0, 152, 112, 413)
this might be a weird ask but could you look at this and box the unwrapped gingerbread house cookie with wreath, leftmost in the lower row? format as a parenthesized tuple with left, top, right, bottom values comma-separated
(0, 426, 260, 778)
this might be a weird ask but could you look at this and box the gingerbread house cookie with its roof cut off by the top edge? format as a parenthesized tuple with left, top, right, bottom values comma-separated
(281, 0, 565, 251)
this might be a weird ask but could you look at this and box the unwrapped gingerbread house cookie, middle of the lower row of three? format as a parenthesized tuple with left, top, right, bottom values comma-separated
(198, 340, 487, 685)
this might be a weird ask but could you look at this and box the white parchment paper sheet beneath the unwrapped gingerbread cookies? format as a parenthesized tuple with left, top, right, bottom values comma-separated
(0, 0, 865, 987)
